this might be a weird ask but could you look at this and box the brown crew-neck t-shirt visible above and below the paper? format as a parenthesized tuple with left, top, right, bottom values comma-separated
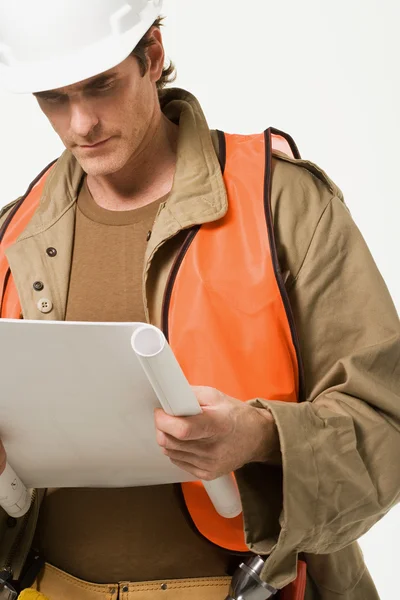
(34, 182, 229, 583)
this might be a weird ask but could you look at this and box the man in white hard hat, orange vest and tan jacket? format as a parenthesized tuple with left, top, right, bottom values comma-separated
(0, 0, 400, 600)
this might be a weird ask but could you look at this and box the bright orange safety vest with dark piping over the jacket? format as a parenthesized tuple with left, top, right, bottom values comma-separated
(0, 129, 305, 598)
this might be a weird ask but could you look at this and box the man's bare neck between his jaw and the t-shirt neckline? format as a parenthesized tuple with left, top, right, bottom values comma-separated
(87, 114, 178, 210)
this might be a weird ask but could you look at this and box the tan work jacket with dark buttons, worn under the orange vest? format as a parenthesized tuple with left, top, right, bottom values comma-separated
(0, 90, 400, 600)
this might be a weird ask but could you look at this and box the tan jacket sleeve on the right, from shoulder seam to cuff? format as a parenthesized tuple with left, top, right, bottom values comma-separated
(238, 197, 400, 587)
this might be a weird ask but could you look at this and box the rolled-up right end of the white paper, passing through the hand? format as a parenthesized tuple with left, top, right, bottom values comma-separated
(131, 325, 242, 519)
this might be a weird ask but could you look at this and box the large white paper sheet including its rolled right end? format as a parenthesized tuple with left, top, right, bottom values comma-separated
(0, 319, 241, 517)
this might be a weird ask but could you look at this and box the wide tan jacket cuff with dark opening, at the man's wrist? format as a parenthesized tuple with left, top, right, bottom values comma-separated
(236, 399, 318, 588)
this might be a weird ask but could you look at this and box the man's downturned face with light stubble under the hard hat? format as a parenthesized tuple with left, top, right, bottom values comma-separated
(35, 56, 158, 176)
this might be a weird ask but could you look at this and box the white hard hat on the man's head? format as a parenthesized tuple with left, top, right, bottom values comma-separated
(0, 0, 162, 93)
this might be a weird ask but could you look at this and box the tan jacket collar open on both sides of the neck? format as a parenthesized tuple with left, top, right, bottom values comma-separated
(19, 88, 227, 241)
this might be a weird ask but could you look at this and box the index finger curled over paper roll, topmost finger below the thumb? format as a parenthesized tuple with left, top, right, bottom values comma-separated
(154, 408, 220, 441)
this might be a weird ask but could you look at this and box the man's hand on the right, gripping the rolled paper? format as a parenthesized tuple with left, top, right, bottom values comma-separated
(155, 387, 280, 481)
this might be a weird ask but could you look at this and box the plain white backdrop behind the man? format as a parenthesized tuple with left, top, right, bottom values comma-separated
(0, 0, 400, 600)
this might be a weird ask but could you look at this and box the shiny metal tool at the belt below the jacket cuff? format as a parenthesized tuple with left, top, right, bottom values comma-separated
(225, 556, 278, 600)
